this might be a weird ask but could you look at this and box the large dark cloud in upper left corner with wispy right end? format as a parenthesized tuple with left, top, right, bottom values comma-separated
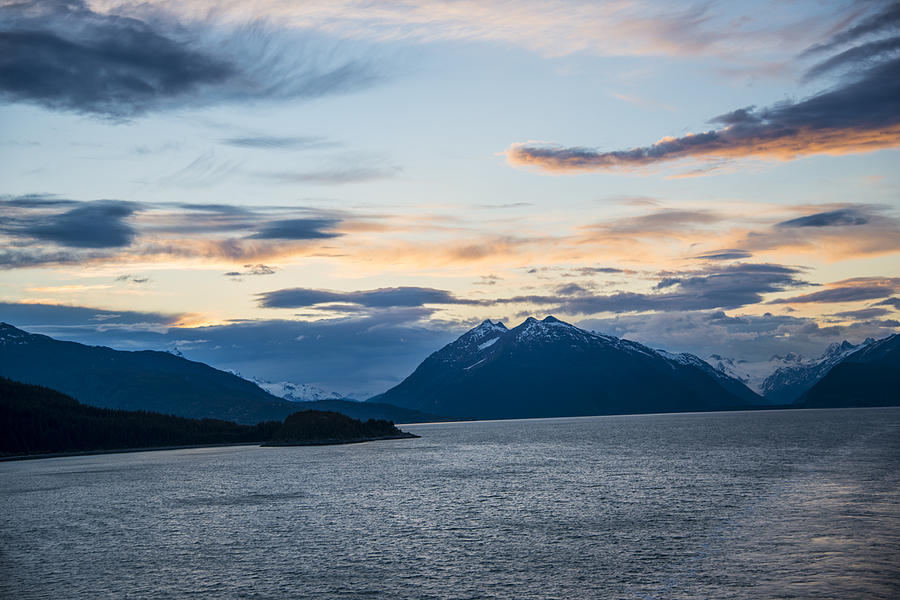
(0, 0, 376, 118)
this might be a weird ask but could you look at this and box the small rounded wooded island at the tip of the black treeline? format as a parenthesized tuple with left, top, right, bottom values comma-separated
(262, 410, 419, 446)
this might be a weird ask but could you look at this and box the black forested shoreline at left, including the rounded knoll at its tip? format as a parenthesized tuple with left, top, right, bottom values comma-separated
(0, 377, 414, 456)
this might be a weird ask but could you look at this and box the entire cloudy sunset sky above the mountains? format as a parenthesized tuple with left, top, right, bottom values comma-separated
(0, 0, 900, 397)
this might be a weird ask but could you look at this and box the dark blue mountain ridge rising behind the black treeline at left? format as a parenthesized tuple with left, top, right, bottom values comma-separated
(0, 323, 434, 424)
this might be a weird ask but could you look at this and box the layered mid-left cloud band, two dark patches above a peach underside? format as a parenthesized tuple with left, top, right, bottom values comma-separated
(0, 196, 356, 269)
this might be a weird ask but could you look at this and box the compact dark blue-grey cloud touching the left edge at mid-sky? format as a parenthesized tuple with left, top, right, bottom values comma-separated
(0, 200, 139, 248)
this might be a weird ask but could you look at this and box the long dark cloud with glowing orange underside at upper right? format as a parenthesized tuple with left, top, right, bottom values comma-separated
(506, 21, 900, 173)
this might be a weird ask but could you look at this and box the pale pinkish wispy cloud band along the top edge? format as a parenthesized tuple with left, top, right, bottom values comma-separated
(108, 0, 849, 60)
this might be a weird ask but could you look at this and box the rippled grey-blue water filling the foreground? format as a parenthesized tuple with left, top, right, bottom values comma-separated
(0, 409, 900, 600)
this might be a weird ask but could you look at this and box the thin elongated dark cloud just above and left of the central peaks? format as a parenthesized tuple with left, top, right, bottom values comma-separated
(259, 287, 484, 308)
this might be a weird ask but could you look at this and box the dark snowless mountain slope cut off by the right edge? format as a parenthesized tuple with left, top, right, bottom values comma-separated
(800, 334, 900, 408)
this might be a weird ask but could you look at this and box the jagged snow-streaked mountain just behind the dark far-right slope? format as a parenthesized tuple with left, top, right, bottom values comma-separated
(759, 339, 873, 404)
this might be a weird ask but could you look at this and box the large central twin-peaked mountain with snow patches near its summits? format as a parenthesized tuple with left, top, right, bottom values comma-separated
(373, 317, 761, 419)
